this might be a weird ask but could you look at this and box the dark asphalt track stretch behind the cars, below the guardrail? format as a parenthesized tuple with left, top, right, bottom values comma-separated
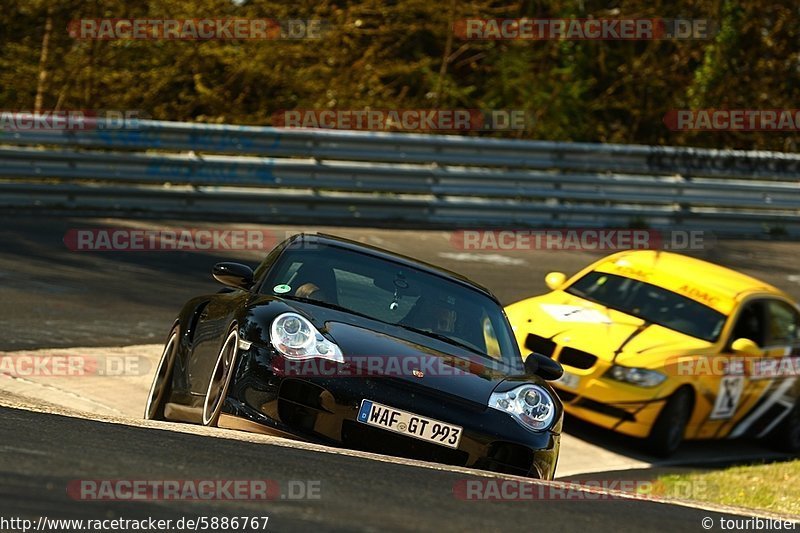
(0, 216, 800, 351)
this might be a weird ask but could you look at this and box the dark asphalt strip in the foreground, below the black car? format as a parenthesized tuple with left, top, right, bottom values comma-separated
(0, 402, 756, 531)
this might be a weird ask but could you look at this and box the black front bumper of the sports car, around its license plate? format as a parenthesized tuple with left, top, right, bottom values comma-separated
(223, 353, 562, 479)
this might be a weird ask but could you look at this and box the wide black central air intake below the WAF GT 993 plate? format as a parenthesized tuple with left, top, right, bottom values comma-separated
(342, 420, 469, 466)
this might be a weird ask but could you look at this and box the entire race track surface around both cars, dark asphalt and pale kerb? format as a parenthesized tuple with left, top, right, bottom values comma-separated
(0, 216, 800, 531)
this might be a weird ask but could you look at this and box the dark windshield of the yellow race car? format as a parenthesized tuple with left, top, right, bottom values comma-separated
(566, 271, 725, 342)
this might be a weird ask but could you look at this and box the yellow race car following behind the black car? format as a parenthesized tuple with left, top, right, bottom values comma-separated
(506, 250, 800, 456)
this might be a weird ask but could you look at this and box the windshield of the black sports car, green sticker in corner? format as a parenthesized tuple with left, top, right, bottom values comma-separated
(261, 244, 521, 364)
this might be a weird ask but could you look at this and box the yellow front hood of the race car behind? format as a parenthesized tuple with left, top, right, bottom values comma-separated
(506, 291, 712, 366)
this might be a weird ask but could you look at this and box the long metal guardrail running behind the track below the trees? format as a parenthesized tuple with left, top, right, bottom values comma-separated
(0, 121, 800, 236)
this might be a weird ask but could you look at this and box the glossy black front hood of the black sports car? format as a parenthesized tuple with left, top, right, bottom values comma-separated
(251, 298, 538, 407)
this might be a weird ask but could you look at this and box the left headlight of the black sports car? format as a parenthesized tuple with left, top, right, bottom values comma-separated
(270, 313, 344, 363)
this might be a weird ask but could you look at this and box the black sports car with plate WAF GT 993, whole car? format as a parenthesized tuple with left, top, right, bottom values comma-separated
(145, 234, 563, 479)
